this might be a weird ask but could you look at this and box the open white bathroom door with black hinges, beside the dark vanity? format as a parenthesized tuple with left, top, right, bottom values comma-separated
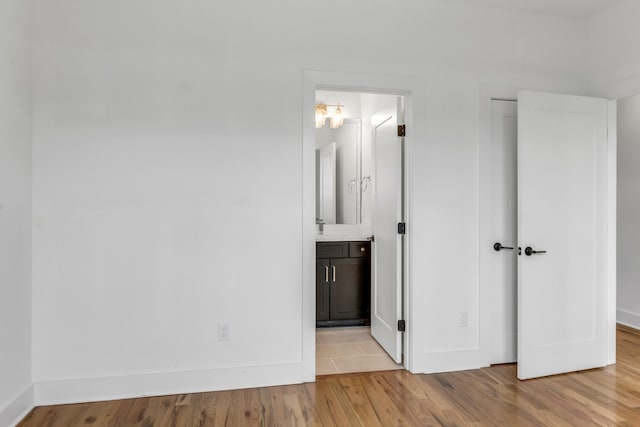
(371, 100, 402, 363)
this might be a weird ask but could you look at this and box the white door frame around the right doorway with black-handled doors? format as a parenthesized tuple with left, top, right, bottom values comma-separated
(478, 86, 617, 366)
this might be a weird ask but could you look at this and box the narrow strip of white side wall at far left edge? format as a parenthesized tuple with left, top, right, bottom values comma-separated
(0, 0, 33, 425)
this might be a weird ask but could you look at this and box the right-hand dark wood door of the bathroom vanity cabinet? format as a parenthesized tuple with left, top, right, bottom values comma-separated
(329, 258, 370, 320)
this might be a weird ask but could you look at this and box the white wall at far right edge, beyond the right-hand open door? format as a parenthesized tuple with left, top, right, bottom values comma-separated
(586, 0, 640, 328)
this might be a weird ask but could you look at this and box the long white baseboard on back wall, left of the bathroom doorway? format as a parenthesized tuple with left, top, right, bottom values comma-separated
(34, 364, 303, 406)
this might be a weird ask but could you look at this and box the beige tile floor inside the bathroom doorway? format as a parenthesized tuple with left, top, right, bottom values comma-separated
(316, 326, 402, 375)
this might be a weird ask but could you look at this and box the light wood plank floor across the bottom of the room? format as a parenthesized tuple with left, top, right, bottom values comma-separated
(20, 326, 640, 427)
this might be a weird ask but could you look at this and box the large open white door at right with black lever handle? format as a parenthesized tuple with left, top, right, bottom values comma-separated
(518, 92, 608, 379)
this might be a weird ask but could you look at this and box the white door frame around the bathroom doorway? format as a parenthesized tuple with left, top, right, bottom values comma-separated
(301, 70, 426, 382)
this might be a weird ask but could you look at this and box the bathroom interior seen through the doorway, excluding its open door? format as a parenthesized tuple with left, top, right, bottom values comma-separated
(315, 90, 403, 375)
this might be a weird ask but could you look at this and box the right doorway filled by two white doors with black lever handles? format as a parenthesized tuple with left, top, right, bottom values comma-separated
(480, 92, 615, 379)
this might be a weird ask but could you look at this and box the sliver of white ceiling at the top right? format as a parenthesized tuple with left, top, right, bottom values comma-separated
(447, 0, 623, 18)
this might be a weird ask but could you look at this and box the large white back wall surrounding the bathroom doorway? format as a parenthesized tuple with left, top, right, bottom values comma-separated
(33, 0, 587, 403)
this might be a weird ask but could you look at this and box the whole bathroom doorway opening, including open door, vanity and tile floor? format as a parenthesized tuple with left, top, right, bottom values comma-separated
(315, 90, 404, 375)
